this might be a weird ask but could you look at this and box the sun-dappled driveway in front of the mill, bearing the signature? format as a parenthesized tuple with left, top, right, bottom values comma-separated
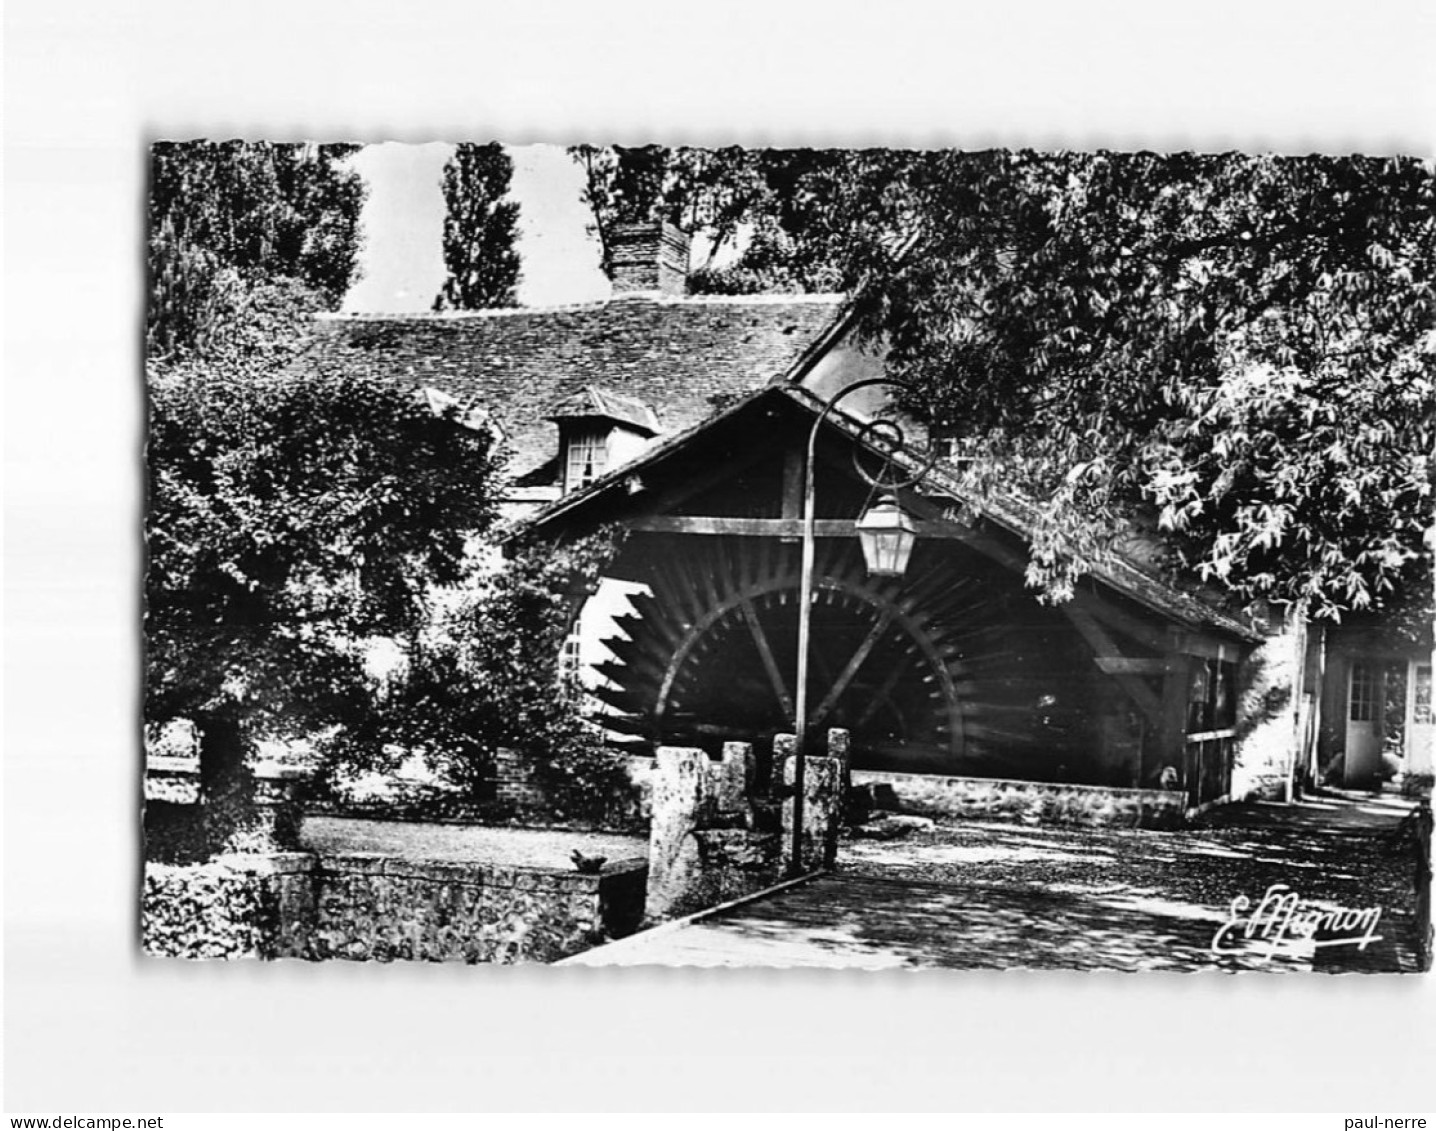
(569, 801, 1419, 972)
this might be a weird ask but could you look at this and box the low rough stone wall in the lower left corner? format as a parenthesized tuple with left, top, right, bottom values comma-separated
(142, 853, 648, 963)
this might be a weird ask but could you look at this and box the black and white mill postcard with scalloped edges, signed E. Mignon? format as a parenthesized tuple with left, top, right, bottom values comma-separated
(142, 136, 1436, 973)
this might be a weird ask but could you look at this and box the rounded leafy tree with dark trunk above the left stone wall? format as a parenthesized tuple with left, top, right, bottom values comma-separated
(145, 340, 495, 844)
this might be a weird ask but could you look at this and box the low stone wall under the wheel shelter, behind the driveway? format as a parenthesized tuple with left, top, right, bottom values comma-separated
(853, 769, 1186, 828)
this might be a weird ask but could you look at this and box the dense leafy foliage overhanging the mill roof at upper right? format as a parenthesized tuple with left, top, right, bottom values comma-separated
(574, 146, 1436, 617)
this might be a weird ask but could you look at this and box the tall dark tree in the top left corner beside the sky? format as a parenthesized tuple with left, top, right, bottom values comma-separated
(145, 141, 363, 359)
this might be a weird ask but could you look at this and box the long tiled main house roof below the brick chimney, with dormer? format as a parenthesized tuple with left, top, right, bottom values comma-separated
(302, 294, 843, 477)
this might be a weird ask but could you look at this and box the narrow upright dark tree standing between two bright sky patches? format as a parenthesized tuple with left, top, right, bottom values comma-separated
(434, 142, 518, 310)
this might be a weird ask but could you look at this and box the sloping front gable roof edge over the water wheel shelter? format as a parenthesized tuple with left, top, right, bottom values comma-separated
(522, 385, 1261, 642)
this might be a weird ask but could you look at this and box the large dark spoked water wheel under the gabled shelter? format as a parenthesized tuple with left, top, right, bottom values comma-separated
(596, 537, 978, 762)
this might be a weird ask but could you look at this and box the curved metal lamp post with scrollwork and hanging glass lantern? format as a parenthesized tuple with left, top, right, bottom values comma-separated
(788, 377, 936, 876)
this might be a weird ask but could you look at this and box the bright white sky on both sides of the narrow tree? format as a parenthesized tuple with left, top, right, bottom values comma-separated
(342, 142, 609, 314)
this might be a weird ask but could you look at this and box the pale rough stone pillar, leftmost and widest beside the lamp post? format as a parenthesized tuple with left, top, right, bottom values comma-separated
(645, 746, 714, 919)
